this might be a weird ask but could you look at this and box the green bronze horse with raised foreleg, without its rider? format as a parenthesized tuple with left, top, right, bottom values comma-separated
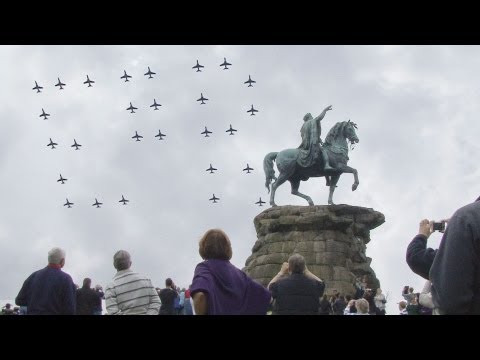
(263, 120, 359, 206)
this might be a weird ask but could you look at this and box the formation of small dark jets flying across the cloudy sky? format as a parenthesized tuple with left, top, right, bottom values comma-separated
(32, 57, 265, 208)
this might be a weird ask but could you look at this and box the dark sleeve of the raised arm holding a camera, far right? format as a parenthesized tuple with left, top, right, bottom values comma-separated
(407, 234, 437, 280)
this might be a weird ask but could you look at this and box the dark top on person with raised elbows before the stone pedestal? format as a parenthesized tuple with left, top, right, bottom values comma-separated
(270, 274, 325, 315)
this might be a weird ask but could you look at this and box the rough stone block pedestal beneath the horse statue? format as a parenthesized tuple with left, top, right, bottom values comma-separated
(243, 205, 385, 295)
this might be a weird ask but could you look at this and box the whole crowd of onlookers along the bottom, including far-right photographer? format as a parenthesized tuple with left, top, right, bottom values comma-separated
(10, 194, 480, 315)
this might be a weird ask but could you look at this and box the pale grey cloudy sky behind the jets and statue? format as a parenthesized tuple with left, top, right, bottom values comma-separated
(0, 45, 480, 314)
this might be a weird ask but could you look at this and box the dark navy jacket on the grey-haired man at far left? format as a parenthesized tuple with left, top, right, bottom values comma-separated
(15, 266, 76, 315)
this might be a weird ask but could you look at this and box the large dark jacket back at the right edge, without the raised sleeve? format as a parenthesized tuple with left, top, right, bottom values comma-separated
(430, 201, 480, 314)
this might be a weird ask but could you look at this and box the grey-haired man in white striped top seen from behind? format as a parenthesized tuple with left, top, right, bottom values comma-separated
(105, 250, 160, 315)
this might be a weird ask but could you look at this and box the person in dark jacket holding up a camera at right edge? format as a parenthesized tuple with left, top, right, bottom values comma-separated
(407, 197, 480, 314)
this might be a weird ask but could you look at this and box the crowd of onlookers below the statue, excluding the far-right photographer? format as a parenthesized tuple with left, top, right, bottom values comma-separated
(9, 229, 392, 315)
